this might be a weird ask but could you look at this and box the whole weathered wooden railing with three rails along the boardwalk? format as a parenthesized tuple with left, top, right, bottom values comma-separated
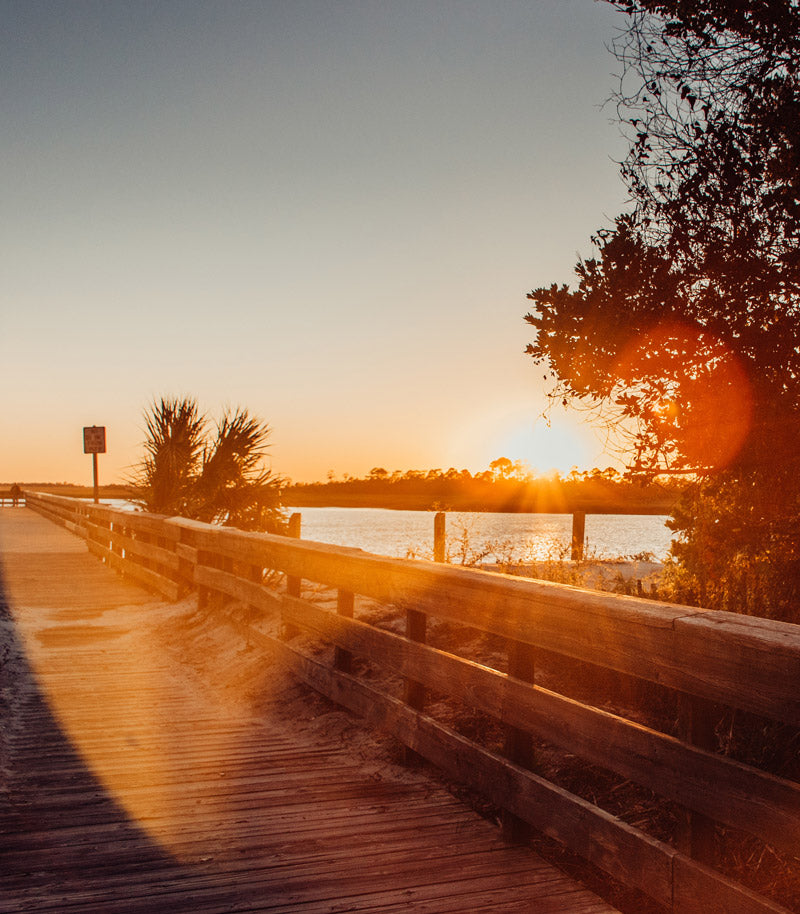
(28, 493, 800, 914)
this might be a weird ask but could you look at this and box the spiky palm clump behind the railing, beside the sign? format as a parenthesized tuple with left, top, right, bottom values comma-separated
(134, 397, 285, 532)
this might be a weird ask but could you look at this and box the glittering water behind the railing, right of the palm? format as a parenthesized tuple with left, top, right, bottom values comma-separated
(288, 508, 671, 562)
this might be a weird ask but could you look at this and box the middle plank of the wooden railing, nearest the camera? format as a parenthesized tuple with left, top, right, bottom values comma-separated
(283, 598, 800, 854)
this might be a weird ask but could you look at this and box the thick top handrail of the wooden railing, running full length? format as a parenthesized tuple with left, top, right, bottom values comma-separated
(23, 493, 800, 726)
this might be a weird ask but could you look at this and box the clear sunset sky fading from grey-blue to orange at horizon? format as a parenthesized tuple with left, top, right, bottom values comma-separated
(0, 0, 626, 484)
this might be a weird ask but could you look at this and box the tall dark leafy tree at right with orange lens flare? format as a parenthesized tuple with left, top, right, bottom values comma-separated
(526, 0, 800, 621)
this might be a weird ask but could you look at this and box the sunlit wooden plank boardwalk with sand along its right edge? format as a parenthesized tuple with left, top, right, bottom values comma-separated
(0, 509, 613, 914)
